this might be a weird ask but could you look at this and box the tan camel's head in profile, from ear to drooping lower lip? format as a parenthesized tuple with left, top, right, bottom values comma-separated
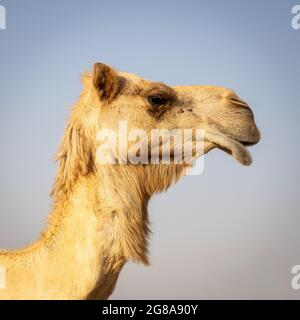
(93, 63, 260, 165)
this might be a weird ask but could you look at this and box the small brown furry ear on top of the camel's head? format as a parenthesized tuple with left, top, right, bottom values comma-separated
(93, 62, 119, 102)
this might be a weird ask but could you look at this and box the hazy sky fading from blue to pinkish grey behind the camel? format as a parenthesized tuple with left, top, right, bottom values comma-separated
(0, 0, 300, 299)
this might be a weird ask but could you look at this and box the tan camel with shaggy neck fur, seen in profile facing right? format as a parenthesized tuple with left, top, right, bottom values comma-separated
(0, 63, 260, 300)
